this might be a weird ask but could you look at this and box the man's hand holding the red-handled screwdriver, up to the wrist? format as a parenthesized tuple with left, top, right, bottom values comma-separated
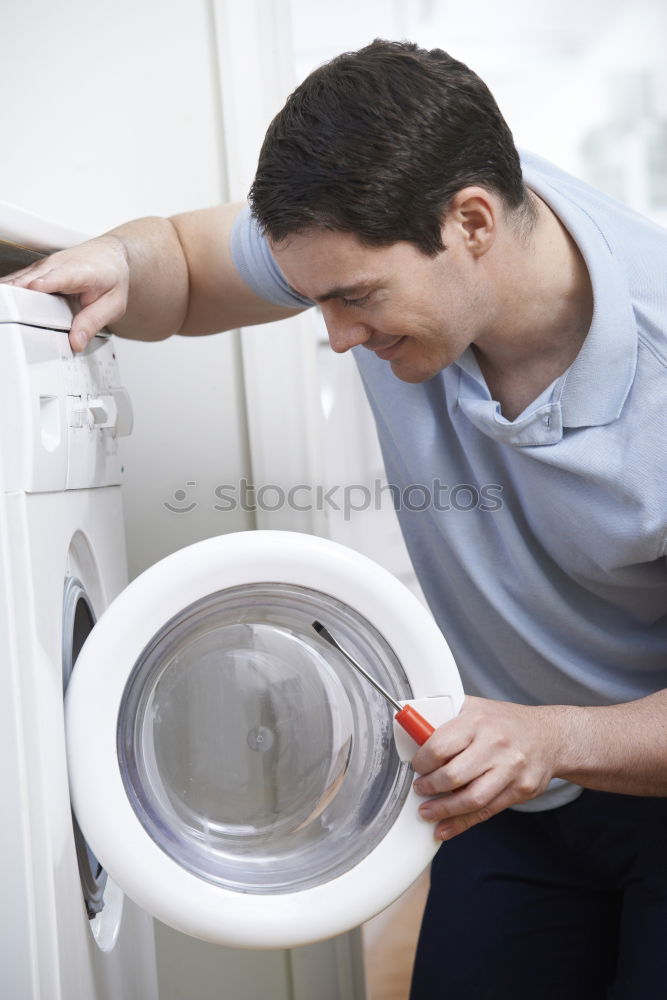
(412, 697, 567, 840)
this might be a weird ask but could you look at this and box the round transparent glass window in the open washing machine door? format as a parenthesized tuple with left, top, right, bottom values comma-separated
(117, 582, 411, 893)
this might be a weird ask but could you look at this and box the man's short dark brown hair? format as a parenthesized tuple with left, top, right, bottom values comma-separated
(250, 39, 531, 255)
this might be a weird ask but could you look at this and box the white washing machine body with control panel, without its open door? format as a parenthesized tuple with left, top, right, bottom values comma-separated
(0, 276, 157, 1000)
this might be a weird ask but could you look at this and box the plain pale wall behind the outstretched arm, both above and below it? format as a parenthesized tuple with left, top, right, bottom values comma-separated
(0, 0, 254, 576)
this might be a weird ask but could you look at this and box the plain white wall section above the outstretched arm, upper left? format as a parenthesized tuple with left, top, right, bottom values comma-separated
(0, 0, 224, 232)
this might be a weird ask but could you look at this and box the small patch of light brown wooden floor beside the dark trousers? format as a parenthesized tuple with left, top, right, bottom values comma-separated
(363, 872, 428, 1000)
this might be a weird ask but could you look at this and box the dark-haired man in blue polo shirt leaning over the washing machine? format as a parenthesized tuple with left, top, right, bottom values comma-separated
(9, 42, 667, 1000)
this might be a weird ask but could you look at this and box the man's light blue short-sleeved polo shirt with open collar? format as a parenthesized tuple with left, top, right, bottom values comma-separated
(232, 154, 667, 809)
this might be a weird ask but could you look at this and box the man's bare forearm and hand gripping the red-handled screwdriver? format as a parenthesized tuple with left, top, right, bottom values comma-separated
(412, 689, 667, 840)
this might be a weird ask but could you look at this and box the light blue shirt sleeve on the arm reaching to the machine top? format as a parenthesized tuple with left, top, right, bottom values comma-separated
(230, 205, 314, 309)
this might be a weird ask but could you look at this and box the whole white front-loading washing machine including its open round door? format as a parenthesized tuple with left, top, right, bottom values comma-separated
(0, 209, 463, 968)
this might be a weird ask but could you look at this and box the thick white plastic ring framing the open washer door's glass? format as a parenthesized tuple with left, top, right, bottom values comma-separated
(66, 531, 463, 947)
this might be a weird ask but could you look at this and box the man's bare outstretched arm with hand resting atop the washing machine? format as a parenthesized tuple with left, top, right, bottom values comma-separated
(1, 205, 306, 350)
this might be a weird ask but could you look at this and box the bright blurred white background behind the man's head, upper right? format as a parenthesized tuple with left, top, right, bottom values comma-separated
(290, 0, 667, 223)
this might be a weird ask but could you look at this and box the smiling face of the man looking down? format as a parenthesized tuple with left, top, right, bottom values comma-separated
(272, 226, 494, 382)
